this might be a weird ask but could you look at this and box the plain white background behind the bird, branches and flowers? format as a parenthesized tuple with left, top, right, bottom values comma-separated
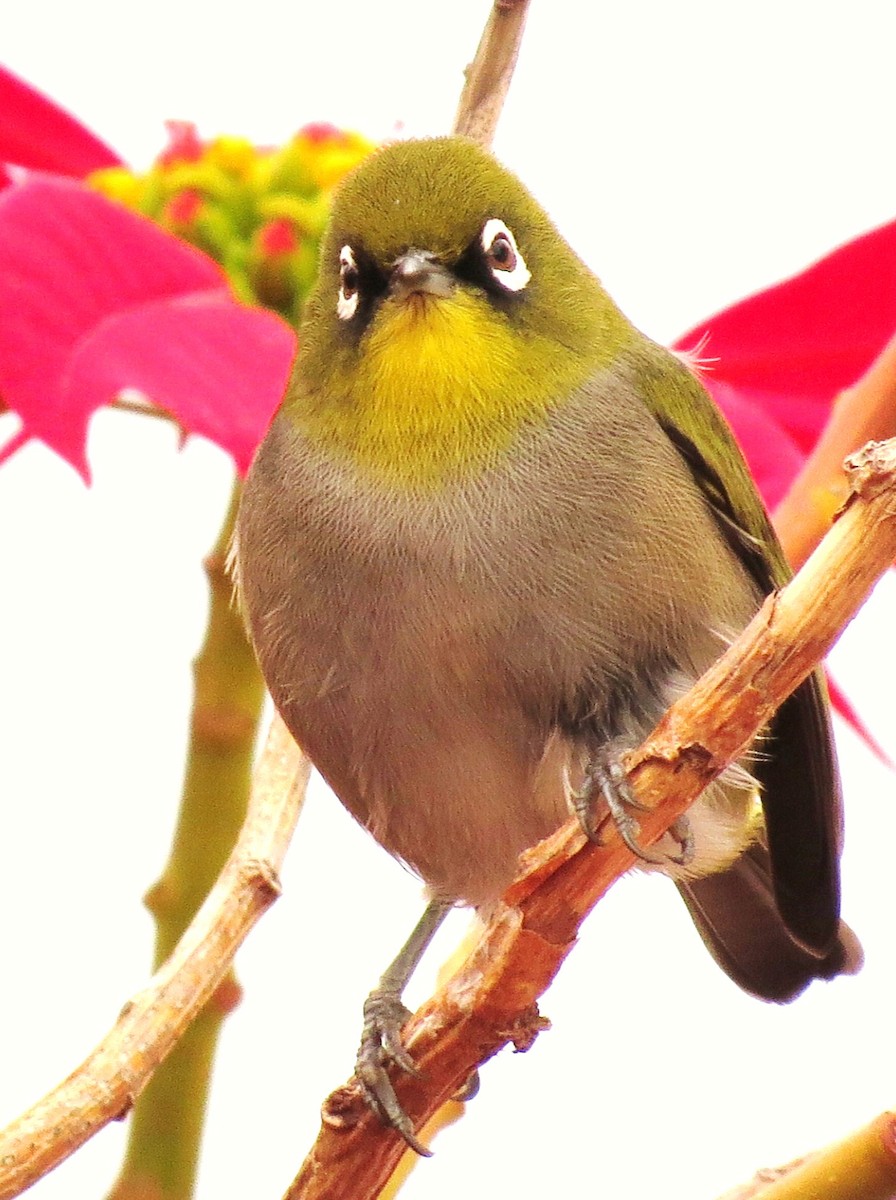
(0, 0, 896, 1200)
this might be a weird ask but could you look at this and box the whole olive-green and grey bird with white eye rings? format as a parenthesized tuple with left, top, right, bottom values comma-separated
(235, 137, 861, 1153)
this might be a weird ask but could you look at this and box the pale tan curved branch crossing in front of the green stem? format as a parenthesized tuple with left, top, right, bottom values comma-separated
(0, 719, 309, 1200)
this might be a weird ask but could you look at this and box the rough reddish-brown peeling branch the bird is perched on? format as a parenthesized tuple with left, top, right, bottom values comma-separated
(285, 440, 896, 1200)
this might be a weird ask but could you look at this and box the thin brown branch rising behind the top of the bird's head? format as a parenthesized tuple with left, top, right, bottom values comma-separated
(453, 0, 529, 146)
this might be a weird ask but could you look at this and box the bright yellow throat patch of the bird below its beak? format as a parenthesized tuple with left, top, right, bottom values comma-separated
(296, 288, 603, 490)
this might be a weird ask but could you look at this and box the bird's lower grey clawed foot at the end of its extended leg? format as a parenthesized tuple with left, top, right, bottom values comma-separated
(355, 988, 432, 1158)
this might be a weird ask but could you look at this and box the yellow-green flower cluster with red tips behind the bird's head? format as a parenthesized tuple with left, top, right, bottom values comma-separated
(88, 122, 373, 323)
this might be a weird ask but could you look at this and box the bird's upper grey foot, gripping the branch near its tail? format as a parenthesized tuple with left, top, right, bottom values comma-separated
(572, 750, 694, 866)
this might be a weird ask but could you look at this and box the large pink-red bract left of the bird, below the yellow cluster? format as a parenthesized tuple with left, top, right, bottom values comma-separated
(0, 176, 295, 478)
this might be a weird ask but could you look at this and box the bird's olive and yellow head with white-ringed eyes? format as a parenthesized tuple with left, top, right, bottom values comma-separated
(288, 137, 630, 492)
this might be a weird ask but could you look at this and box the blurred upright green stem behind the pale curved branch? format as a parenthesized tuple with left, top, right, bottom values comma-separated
(109, 484, 264, 1200)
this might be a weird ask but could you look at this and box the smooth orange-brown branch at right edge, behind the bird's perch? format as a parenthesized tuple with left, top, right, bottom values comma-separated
(775, 336, 896, 568)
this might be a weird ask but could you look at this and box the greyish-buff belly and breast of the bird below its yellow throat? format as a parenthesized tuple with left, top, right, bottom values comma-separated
(239, 379, 756, 904)
